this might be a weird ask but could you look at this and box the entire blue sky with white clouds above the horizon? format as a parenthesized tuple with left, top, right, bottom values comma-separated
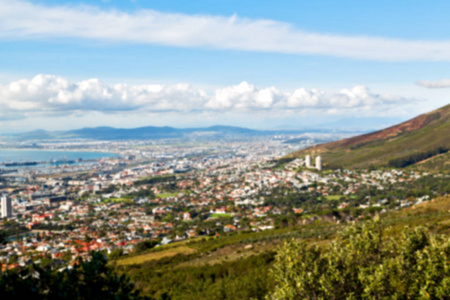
(0, 0, 450, 133)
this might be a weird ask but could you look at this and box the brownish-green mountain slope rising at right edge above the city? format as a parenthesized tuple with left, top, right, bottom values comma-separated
(288, 105, 450, 168)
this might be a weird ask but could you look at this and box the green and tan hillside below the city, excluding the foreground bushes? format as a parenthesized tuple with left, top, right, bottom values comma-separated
(111, 197, 450, 299)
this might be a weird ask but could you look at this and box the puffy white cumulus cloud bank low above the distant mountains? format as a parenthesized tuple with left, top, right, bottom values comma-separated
(0, 74, 409, 116)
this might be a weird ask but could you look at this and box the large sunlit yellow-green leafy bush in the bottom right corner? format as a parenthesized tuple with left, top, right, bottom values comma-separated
(270, 221, 450, 299)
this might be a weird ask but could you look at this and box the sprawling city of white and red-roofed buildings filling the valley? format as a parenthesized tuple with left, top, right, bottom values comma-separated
(0, 137, 448, 270)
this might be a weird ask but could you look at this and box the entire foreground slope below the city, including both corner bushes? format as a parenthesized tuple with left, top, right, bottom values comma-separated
(0, 196, 450, 299)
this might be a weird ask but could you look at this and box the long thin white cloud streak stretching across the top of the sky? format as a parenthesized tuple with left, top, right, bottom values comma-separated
(0, 0, 450, 61)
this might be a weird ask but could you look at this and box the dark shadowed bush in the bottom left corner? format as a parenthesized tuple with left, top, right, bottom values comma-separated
(0, 253, 142, 300)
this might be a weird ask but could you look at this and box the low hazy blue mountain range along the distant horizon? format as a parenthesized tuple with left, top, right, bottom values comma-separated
(3, 125, 356, 141)
